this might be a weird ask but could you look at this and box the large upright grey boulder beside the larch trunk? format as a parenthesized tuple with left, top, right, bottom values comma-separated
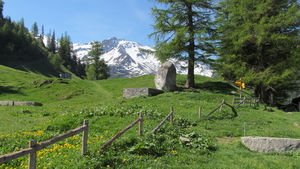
(154, 61, 177, 91)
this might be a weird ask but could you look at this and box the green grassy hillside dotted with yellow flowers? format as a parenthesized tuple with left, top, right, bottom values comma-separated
(0, 66, 300, 168)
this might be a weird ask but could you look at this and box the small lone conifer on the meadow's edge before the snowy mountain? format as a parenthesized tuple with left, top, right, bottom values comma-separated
(86, 41, 110, 80)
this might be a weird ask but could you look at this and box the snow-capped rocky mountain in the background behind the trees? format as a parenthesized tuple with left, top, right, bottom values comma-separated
(73, 37, 212, 78)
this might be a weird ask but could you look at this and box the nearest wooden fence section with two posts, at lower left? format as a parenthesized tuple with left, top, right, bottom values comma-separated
(0, 120, 89, 169)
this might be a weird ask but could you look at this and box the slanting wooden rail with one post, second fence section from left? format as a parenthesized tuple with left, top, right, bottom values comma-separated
(100, 113, 143, 150)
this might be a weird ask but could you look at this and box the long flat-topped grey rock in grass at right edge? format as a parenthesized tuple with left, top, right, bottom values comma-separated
(242, 137, 300, 153)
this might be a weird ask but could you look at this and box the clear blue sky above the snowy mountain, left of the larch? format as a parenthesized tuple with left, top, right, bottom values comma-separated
(3, 0, 162, 46)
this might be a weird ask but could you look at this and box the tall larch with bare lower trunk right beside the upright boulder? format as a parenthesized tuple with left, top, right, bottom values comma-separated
(149, 0, 213, 88)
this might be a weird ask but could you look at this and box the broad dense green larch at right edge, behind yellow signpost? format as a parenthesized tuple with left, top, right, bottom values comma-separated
(216, 0, 300, 101)
